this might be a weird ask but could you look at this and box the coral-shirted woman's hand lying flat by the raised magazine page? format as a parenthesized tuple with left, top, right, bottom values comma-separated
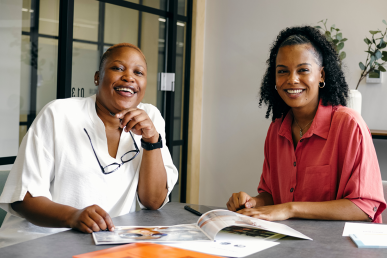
(237, 203, 293, 221)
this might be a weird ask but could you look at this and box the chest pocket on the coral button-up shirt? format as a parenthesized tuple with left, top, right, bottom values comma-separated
(301, 165, 331, 202)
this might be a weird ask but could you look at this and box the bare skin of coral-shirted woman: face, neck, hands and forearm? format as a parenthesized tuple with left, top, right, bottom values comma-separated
(227, 45, 370, 221)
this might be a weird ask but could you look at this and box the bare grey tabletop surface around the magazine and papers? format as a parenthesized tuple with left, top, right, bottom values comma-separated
(0, 203, 387, 258)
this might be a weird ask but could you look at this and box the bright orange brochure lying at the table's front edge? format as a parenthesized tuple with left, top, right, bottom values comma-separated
(73, 243, 223, 258)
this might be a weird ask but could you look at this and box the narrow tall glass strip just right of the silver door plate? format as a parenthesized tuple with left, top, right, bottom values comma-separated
(173, 22, 186, 140)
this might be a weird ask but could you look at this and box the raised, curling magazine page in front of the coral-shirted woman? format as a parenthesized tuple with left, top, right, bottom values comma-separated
(197, 210, 312, 240)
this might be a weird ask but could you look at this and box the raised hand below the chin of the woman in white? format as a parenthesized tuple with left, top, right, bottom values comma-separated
(116, 108, 159, 143)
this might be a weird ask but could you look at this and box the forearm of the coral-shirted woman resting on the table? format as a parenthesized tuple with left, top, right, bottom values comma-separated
(287, 199, 370, 221)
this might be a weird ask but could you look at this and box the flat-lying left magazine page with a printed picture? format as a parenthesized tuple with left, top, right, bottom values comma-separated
(93, 224, 211, 245)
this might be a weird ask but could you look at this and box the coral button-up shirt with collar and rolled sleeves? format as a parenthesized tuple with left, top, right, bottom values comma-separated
(258, 102, 386, 223)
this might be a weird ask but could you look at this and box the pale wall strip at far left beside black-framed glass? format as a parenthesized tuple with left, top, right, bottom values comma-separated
(0, 0, 22, 170)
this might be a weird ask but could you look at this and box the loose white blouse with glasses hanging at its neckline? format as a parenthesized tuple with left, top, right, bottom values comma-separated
(0, 95, 178, 247)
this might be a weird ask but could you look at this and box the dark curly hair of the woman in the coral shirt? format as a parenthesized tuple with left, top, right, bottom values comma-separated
(259, 26, 348, 121)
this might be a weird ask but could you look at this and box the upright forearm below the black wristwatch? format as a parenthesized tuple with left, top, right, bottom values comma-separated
(137, 149, 168, 210)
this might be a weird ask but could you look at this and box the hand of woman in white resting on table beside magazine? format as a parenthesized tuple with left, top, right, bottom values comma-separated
(67, 205, 114, 233)
